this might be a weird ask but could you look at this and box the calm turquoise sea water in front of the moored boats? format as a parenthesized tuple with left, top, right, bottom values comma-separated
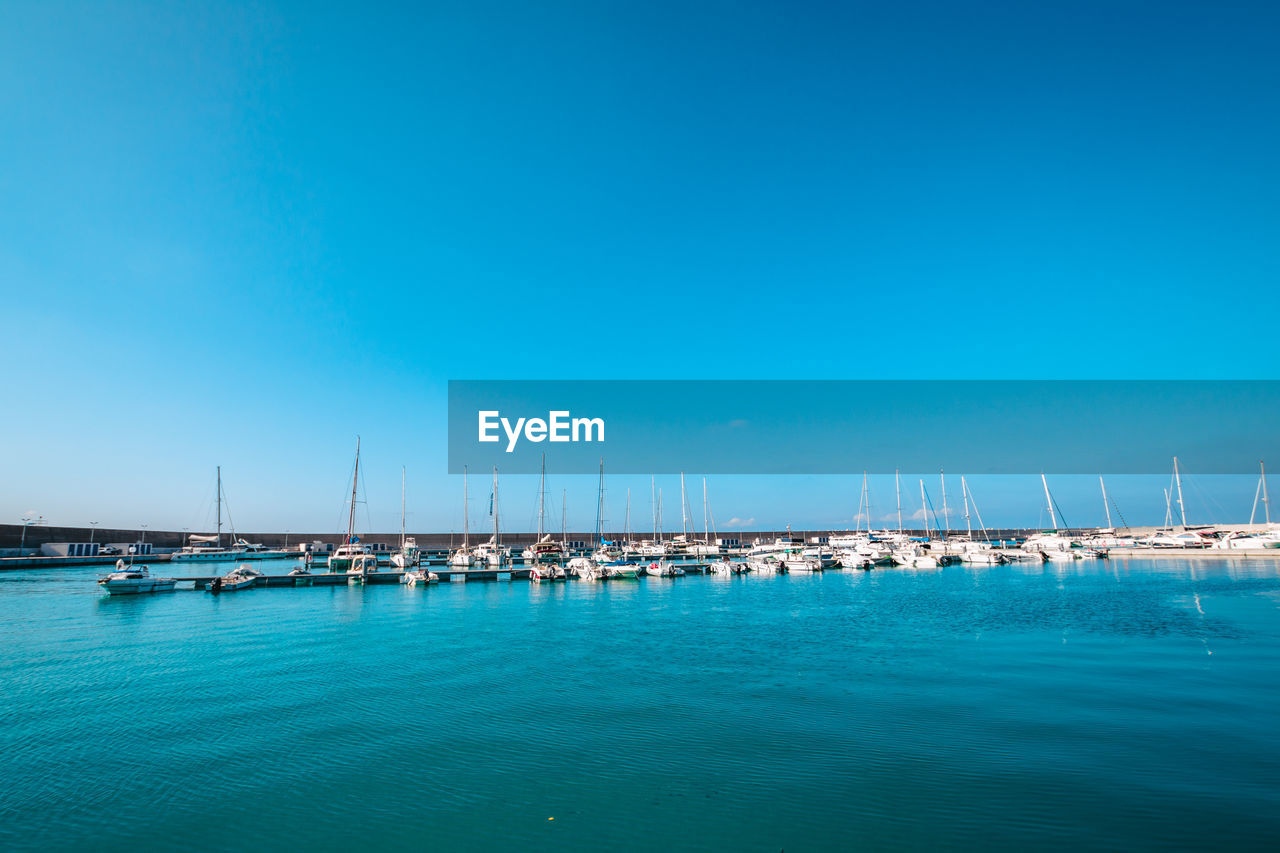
(0, 560, 1280, 852)
